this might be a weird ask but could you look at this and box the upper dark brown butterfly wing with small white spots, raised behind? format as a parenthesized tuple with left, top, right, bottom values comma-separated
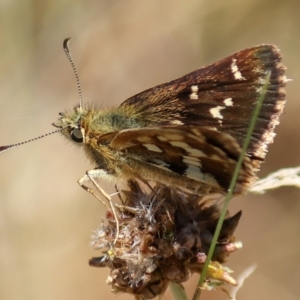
(121, 45, 286, 175)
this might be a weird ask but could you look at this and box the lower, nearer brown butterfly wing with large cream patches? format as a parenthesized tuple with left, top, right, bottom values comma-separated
(110, 126, 255, 193)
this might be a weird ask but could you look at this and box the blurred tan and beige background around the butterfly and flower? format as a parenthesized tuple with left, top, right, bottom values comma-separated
(0, 0, 300, 300)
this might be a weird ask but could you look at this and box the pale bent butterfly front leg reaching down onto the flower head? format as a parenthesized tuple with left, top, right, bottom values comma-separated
(78, 169, 119, 244)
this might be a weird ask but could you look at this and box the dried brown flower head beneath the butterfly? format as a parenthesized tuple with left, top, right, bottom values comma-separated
(90, 182, 241, 299)
